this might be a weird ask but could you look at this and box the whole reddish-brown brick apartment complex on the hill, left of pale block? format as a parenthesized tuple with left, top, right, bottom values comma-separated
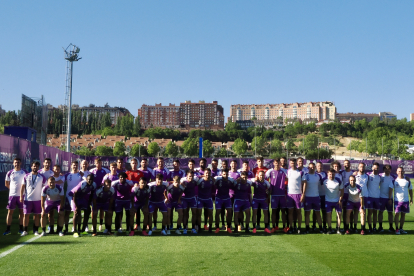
(138, 101, 224, 128)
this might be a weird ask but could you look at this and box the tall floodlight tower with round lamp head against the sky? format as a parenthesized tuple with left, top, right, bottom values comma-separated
(63, 43, 81, 152)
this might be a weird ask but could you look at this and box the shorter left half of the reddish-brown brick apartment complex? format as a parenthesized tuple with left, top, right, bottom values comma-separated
(138, 103, 180, 128)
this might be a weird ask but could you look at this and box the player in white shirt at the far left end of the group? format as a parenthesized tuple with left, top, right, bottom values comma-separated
(3, 157, 27, 236)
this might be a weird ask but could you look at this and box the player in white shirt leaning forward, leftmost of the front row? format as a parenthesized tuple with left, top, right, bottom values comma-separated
(40, 176, 65, 236)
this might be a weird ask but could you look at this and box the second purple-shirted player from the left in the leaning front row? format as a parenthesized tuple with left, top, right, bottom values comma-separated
(92, 179, 115, 236)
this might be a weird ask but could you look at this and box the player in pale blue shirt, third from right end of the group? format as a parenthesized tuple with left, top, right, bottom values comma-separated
(367, 162, 383, 233)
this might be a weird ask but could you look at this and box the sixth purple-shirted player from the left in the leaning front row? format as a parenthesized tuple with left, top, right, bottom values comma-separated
(167, 175, 185, 235)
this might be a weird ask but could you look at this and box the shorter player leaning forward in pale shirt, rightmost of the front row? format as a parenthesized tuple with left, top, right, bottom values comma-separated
(344, 175, 365, 235)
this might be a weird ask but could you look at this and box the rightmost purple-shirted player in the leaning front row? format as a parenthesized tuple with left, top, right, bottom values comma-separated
(252, 171, 270, 234)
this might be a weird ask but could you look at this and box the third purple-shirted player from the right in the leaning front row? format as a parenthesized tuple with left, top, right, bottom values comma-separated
(214, 169, 235, 234)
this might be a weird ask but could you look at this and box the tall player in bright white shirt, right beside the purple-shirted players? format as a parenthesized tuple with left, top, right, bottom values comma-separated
(286, 159, 303, 234)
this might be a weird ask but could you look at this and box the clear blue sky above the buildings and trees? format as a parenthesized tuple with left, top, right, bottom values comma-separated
(0, 1, 414, 118)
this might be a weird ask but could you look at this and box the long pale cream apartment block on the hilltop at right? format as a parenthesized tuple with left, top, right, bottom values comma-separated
(228, 102, 336, 122)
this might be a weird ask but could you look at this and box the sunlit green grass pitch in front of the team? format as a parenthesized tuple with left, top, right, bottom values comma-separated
(0, 192, 414, 276)
